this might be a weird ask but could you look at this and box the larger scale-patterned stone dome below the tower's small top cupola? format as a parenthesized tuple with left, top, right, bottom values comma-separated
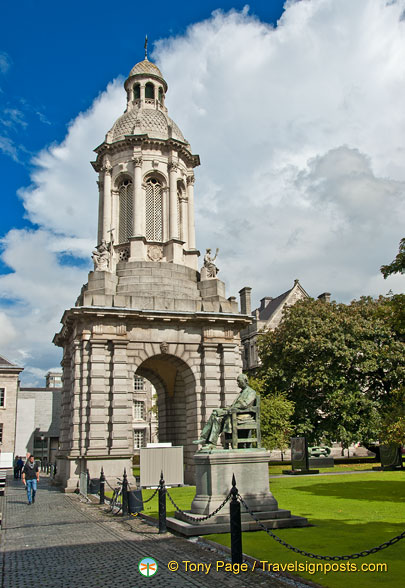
(110, 107, 186, 143)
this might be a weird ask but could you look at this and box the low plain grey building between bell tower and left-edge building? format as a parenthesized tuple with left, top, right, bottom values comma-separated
(15, 372, 62, 463)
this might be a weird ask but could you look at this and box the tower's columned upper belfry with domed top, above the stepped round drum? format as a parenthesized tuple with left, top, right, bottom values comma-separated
(93, 52, 200, 270)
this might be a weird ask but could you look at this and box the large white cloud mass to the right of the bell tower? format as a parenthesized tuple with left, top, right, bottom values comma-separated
(155, 0, 405, 302)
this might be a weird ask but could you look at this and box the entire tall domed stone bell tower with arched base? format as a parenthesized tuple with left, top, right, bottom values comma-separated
(54, 55, 251, 490)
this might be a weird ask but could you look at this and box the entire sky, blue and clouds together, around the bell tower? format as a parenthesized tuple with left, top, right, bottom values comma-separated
(0, 0, 405, 384)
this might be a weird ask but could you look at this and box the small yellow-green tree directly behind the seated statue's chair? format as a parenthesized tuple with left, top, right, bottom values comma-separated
(249, 378, 294, 451)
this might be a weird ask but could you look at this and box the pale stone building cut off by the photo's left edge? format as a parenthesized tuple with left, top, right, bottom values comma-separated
(0, 356, 24, 466)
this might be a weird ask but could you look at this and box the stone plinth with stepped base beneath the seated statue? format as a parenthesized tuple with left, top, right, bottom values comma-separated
(167, 449, 308, 536)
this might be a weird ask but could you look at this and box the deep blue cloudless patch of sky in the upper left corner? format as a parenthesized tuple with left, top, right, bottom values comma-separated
(0, 0, 284, 241)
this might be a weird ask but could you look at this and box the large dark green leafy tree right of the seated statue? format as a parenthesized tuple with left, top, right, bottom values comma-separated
(258, 297, 405, 447)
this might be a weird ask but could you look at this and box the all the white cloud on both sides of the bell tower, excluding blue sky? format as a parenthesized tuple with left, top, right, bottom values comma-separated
(0, 0, 405, 377)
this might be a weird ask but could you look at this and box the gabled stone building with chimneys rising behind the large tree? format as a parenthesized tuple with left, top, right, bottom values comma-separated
(239, 280, 330, 371)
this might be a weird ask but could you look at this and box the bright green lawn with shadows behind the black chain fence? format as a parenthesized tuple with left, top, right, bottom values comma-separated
(132, 474, 405, 588)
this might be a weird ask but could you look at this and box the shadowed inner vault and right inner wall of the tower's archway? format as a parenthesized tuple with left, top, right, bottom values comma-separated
(134, 352, 198, 481)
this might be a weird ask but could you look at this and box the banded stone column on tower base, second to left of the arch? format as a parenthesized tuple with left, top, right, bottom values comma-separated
(86, 339, 108, 455)
